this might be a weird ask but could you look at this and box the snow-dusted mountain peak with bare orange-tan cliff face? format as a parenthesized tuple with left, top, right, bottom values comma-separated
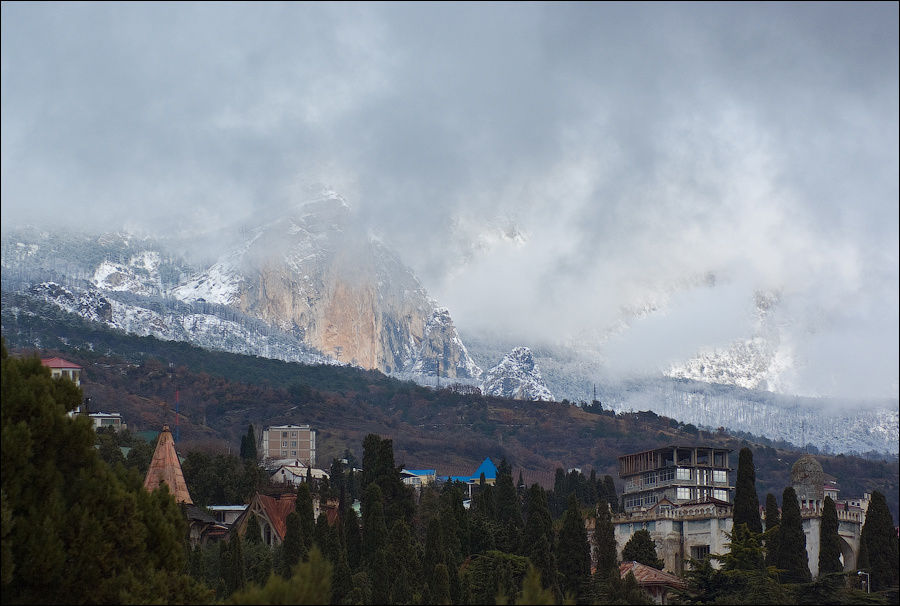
(2, 192, 481, 381)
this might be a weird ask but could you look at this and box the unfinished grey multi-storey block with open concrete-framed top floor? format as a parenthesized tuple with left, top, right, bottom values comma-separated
(619, 446, 734, 513)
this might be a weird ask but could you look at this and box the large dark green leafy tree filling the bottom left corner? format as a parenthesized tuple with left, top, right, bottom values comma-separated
(0, 343, 208, 603)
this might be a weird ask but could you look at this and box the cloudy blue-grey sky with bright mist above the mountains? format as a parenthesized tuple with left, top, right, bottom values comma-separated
(0, 2, 900, 398)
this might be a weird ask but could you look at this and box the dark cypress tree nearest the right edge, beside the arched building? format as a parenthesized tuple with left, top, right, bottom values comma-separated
(860, 490, 898, 591)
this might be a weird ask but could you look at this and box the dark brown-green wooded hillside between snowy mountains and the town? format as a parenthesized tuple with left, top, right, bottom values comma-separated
(3, 300, 898, 516)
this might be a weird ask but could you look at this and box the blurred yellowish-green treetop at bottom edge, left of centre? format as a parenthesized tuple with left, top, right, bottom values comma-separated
(228, 547, 332, 604)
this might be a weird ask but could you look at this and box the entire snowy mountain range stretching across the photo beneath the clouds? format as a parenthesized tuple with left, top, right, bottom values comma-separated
(2, 189, 898, 454)
